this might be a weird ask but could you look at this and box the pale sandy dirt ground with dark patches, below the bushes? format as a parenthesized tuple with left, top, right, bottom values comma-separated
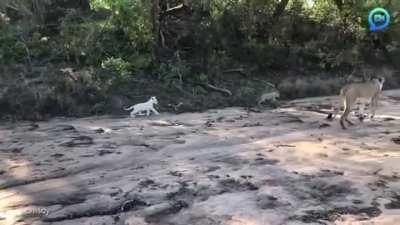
(0, 90, 400, 225)
